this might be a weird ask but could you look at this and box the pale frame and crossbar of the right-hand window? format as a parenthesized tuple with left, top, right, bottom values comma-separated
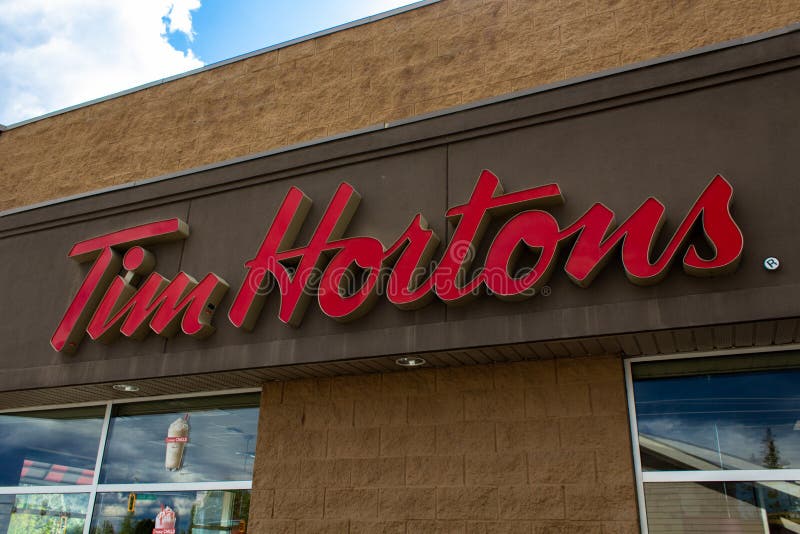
(623, 343, 800, 534)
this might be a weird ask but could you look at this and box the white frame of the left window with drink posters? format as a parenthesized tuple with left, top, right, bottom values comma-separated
(0, 388, 262, 534)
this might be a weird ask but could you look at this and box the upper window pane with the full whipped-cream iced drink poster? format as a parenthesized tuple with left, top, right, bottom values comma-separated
(100, 394, 259, 484)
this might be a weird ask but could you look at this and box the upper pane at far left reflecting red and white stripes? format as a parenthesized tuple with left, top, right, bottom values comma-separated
(0, 406, 105, 486)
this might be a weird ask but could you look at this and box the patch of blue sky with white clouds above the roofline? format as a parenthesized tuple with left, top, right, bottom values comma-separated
(0, 0, 422, 125)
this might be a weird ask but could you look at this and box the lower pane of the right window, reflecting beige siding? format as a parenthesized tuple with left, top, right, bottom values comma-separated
(645, 482, 800, 534)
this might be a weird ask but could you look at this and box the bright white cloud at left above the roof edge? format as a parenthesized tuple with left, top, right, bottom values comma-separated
(0, 0, 203, 124)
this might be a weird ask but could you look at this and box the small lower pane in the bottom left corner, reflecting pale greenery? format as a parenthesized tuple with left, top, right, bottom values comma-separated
(0, 493, 89, 534)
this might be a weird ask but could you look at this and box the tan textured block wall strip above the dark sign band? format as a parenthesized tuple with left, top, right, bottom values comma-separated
(0, 0, 800, 210)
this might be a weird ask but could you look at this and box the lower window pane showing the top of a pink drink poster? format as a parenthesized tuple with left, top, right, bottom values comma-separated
(90, 490, 250, 534)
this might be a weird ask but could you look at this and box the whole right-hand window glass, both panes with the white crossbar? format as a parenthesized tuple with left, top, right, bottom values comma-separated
(628, 351, 800, 534)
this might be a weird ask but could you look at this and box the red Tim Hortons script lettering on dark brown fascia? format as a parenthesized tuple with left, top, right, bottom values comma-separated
(51, 171, 743, 353)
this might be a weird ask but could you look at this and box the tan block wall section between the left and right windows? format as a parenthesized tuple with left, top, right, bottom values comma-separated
(248, 358, 638, 534)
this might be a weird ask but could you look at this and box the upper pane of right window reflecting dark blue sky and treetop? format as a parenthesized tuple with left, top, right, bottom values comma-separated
(634, 362, 800, 471)
